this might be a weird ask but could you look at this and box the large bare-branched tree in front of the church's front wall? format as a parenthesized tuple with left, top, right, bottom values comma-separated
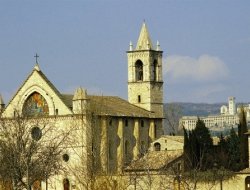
(0, 114, 69, 190)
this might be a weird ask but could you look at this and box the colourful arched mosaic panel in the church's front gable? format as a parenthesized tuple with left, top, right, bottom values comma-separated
(23, 92, 49, 117)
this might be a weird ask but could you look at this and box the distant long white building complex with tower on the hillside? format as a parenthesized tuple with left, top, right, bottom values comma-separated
(179, 97, 250, 130)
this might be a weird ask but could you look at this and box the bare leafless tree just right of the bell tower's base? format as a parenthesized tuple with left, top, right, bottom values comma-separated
(164, 103, 182, 135)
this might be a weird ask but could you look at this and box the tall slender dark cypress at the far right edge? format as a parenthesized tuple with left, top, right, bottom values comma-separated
(238, 106, 248, 169)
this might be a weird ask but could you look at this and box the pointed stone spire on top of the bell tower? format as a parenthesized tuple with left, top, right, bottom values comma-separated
(136, 22, 153, 50)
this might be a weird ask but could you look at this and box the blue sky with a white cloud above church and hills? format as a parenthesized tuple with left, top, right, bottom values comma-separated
(0, 0, 250, 103)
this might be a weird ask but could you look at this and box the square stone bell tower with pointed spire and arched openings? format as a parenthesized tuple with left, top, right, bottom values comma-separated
(127, 22, 163, 117)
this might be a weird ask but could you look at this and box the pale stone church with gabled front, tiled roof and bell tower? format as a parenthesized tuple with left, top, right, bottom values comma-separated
(0, 23, 163, 189)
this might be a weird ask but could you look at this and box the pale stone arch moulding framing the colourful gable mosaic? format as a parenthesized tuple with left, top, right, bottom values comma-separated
(19, 85, 55, 115)
